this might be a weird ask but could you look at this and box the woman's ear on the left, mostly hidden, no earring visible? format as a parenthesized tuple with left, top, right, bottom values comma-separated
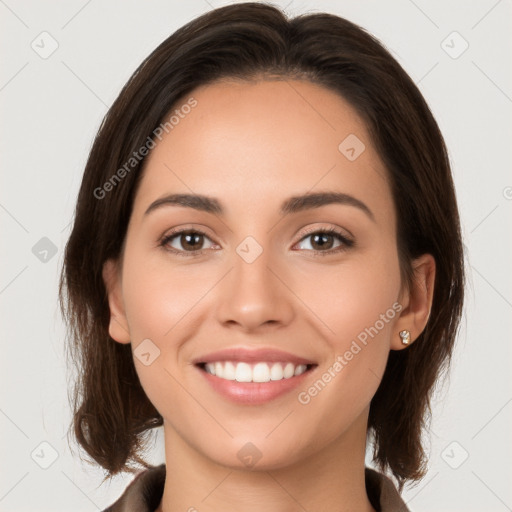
(102, 259, 131, 343)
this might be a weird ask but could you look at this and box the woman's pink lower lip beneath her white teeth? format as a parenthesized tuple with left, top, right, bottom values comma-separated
(198, 367, 314, 405)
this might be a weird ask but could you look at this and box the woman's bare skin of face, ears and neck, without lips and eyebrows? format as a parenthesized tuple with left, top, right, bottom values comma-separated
(103, 80, 435, 512)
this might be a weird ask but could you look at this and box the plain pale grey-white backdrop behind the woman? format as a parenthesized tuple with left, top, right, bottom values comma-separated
(0, 0, 512, 512)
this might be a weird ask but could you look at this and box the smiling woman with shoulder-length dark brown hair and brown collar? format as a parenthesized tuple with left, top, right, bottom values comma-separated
(60, 3, 464, 512)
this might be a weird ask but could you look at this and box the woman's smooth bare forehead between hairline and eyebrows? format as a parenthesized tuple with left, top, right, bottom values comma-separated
(134, 79, 391, 222)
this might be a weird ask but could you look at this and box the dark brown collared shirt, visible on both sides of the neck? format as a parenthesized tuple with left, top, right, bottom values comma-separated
(103, 464, 410, 512)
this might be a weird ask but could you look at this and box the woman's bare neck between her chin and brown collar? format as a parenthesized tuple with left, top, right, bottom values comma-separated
(156, 411, 374, 512)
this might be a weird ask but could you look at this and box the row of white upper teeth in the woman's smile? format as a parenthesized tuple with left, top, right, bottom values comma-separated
(204, 361, 307, 382)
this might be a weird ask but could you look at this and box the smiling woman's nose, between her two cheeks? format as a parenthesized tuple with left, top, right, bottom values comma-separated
(217, 243, 294, 332)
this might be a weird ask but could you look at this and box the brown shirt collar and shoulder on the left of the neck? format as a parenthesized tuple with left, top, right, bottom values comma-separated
(103, 464, 165, 512)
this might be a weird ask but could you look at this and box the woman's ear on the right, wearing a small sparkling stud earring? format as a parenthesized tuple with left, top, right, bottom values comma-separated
(391, 254, 436, 350)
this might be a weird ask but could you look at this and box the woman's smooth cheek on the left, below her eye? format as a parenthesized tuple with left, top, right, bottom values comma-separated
(118, 247, 215, 421)
